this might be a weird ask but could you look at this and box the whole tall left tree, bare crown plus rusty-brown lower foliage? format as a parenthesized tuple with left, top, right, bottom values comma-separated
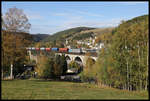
(2, 7, 31, 78)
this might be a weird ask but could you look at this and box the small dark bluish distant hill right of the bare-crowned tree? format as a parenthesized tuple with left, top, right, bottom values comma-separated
(31, 34, 50, 42)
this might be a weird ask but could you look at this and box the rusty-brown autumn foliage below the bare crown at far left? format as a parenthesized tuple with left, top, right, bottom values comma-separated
(2, 31, 30, 74)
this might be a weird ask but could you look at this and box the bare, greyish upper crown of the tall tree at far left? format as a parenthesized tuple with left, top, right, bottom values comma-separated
(3, 7, 31, 32)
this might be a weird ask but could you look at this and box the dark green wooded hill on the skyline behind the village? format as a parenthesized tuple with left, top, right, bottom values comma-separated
(42, 27, 95, 42)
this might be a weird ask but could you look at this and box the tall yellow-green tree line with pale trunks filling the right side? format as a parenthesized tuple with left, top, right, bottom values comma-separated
(82, 15, 149, 91)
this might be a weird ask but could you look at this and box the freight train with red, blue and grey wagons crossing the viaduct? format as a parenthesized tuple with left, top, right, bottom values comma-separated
(27, 47, 96, 53)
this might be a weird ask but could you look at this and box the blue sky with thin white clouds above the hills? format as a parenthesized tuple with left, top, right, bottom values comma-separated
(1, 1, 149, 35)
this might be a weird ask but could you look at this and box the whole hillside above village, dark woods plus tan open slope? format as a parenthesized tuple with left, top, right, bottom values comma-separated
(42, 27, 114, 42)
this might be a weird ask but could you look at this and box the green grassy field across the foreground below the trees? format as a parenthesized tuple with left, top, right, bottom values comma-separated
(1, 80, 148, 99)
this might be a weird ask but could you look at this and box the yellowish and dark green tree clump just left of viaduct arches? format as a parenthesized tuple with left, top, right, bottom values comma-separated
(35, 55, 67, 79)
